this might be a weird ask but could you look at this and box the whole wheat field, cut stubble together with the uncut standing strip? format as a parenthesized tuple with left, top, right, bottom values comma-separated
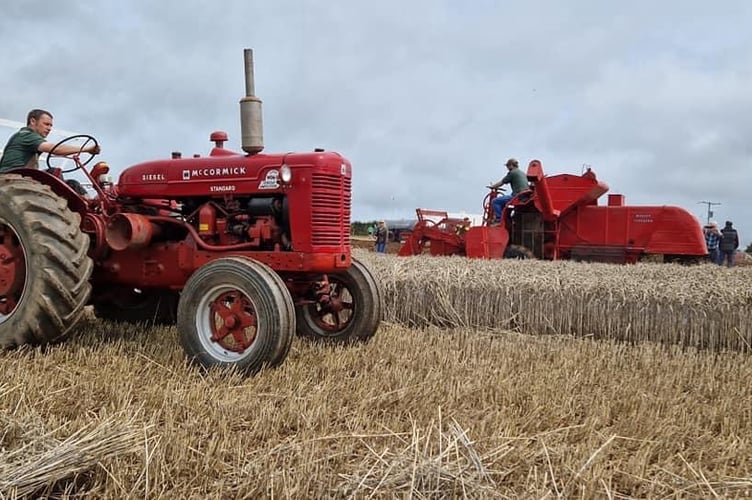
(0, 252, 752, 499)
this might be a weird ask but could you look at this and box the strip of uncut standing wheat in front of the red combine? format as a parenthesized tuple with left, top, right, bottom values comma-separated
(356, 252, 752, 351)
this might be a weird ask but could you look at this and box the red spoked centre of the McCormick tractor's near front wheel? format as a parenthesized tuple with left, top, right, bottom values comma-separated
(208, 290, 258, 356)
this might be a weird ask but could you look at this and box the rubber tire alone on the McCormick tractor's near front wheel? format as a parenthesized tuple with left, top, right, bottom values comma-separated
(177, 257, 295, 375)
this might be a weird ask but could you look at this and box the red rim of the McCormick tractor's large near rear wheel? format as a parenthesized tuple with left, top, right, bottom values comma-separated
(0, 221, 26, 322)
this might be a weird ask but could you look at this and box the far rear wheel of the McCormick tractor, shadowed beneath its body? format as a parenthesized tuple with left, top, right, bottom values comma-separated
(92, 287, 180, 325)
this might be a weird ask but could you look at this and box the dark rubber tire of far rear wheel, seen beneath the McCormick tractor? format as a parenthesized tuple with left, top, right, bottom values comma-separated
(92, 289, 180, 326)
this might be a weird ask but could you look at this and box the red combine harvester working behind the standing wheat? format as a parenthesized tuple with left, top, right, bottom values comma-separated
(399, 160, 707, 264)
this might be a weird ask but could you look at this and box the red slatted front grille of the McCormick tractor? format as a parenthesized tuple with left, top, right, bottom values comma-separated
(311, 174, 352, 246)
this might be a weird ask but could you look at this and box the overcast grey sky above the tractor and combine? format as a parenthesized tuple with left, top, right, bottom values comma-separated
(0, 0, 752, 245)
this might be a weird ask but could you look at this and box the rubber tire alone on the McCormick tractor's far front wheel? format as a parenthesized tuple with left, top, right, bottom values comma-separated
(296, 259, 382, 344)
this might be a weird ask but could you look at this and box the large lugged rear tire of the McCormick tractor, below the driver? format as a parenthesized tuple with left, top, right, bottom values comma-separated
(0, 174, 94, 348)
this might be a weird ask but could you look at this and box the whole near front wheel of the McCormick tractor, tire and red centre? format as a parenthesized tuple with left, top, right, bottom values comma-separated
(177, 257, 295, 374)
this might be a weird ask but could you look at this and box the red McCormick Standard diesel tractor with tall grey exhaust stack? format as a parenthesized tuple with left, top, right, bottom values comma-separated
(0, 49, 381, 373)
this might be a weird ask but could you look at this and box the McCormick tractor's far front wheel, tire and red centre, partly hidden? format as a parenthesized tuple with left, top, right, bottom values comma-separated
(297, 259, 381, 343)
